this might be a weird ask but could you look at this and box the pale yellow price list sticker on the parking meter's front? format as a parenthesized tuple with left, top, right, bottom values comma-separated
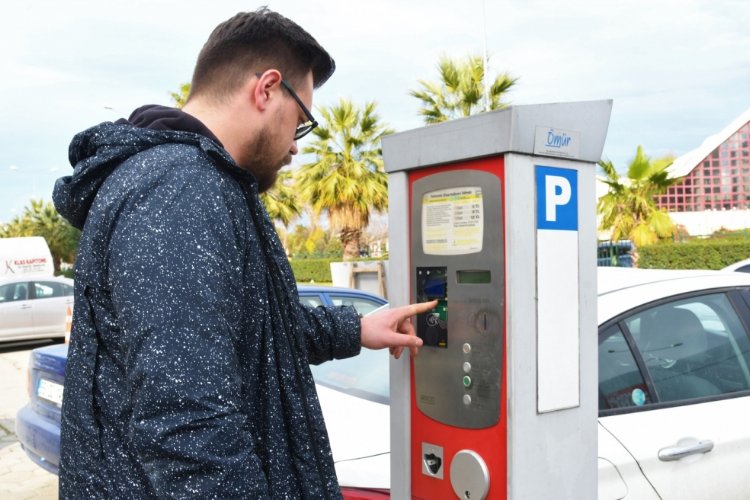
(422, 186, 484, 255)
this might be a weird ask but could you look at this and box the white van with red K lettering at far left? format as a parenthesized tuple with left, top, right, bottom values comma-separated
(0, 236, 55, 280)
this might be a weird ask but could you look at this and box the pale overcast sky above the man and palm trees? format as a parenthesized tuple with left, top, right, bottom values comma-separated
(0, 0, 750, 221)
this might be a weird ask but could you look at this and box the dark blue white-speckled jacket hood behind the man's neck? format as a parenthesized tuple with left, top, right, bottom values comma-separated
(52, 110, 245, 229)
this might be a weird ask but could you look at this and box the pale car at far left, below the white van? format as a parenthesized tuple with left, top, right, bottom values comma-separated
(0, 275, 73, 342)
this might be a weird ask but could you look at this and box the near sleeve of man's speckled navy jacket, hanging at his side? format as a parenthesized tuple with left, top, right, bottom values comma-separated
(109, 169, 269, 499)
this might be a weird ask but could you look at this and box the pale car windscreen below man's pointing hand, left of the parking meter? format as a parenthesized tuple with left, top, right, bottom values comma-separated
(310, 347, 390, 404)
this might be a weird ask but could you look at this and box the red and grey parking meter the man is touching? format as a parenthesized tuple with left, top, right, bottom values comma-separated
(383, 101, 612, 500)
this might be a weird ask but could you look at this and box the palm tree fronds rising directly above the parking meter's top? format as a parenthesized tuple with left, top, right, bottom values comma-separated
(409, 55, 518, 125)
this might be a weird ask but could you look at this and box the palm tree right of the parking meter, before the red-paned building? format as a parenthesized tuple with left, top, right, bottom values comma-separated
(597, 146, 678, 247)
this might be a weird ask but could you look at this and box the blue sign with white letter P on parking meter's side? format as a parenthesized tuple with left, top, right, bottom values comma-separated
(536, 165, 578, 231)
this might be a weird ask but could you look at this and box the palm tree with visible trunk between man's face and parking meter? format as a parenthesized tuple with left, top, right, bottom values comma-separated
(296, 98, 392, 260)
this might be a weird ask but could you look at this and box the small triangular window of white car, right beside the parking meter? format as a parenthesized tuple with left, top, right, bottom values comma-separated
(599, 325, 652, 410)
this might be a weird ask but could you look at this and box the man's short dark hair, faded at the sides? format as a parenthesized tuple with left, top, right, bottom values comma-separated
(190, 7, 336, 100)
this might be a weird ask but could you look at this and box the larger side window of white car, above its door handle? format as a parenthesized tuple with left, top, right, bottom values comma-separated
(624, 293, 750, 402)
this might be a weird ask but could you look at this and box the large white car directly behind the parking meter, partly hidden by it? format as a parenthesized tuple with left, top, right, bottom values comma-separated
(313, 268, 750, 500)
